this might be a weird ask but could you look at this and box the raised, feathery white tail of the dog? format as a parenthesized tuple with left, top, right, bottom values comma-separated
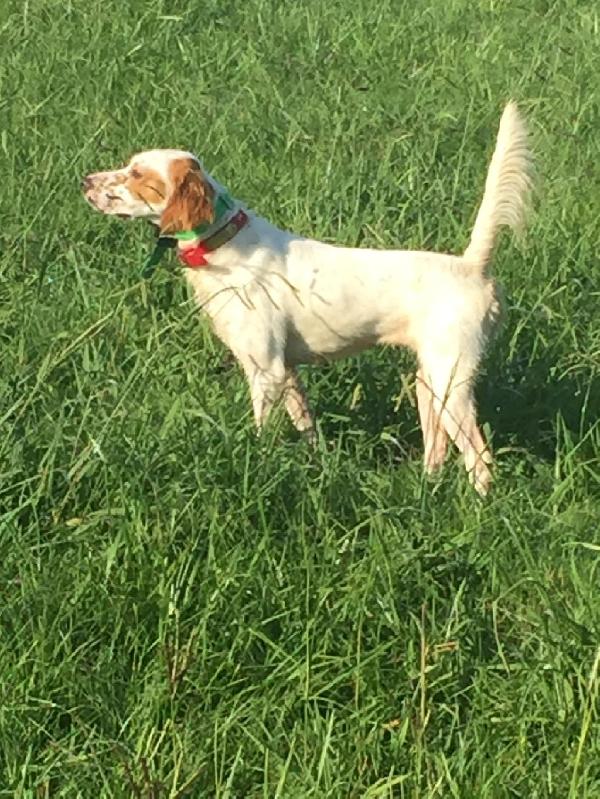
(463, 102, 532, 275)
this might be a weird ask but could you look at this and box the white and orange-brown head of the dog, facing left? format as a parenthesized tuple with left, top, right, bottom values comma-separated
(82, 150, 215, 235)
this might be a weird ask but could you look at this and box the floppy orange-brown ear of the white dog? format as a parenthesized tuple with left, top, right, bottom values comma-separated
(160, 158, 215, 235)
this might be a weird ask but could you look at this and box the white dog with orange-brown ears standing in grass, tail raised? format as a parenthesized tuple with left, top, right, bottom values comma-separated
(82, 102, 532, 495)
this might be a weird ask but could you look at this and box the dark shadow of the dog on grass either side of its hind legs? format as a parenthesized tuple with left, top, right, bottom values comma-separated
(309, 342, 600, 468)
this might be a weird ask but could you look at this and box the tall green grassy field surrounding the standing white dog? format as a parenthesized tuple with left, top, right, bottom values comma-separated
(0, 0, 600, 799)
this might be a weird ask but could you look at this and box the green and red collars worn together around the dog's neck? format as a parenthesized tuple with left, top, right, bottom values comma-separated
(142, 192, 248, 279)
